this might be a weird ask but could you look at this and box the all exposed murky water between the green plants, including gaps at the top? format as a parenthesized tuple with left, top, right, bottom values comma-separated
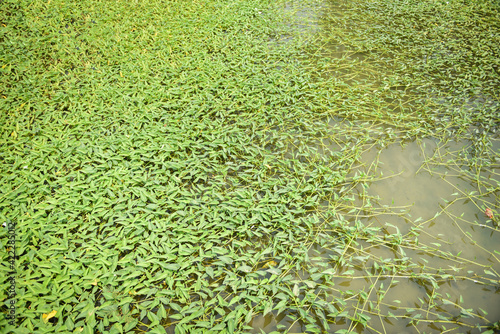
(250, 1, 500, 333)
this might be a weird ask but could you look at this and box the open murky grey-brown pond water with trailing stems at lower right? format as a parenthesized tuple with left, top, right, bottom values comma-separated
(251, 139, 500, 333)
